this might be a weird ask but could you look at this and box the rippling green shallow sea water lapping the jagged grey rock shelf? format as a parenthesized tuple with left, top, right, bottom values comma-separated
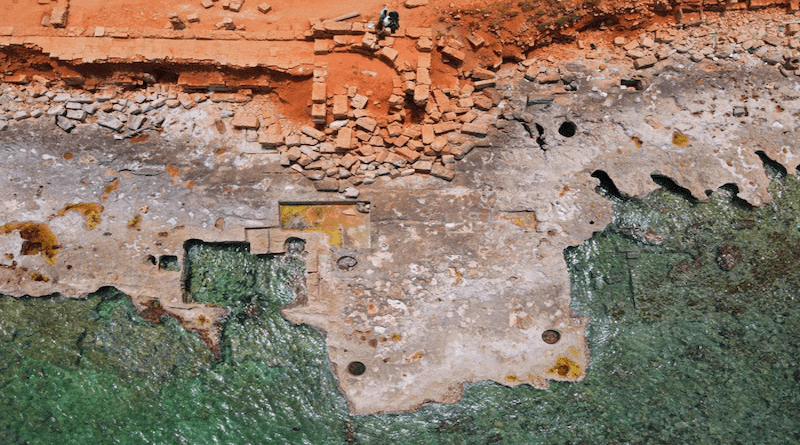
(0, 172, 800, 444)
